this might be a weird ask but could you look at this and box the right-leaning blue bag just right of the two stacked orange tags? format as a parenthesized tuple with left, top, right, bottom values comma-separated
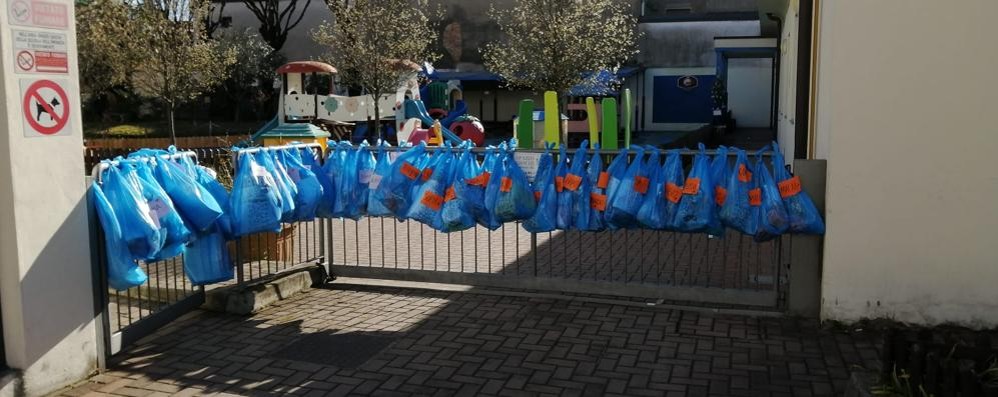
(606, 147, 658, 229)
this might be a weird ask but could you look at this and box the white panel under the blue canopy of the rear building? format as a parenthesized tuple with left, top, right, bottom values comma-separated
(728, 58, 773, 128)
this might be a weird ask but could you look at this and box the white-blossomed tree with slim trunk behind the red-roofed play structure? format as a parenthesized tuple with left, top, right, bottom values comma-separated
(313, 0, 437, 139)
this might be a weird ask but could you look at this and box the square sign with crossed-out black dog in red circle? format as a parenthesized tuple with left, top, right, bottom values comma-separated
(21, 79, 72, 137)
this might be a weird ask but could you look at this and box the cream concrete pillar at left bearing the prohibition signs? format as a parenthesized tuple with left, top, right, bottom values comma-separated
(0, 0, 97, 396)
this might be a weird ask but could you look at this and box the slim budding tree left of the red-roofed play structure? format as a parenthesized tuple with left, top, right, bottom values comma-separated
(128, 0, 236, 143)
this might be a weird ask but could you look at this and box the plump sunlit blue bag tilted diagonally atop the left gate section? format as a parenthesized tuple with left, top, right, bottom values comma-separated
(154, 159, 222, 231)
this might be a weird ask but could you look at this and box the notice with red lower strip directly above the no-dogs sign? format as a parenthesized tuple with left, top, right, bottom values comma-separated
(11, 29, 69, 74)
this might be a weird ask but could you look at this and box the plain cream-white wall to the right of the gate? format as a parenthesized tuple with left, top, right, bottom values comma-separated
(816, 0, 998, 327)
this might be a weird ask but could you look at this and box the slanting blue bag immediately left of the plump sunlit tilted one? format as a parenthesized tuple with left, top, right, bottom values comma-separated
(130, 161, 192, 261)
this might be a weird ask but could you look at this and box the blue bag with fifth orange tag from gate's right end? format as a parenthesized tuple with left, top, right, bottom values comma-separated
(674, 143, 719, 233)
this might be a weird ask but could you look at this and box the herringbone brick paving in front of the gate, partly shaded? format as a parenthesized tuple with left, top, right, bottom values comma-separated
(61, 285, 879, 396)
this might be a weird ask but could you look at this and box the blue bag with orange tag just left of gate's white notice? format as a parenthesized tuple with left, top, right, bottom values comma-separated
(495, 139, 537, 223)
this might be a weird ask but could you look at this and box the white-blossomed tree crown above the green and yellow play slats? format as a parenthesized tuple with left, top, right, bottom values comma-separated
(482, 0, 639, 99)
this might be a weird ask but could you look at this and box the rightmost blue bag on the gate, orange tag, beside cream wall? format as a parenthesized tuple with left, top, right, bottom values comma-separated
(773, 142, 825, 234)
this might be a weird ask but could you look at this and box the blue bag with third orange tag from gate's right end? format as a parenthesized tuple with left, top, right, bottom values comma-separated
(718, 148, 760, 236)
